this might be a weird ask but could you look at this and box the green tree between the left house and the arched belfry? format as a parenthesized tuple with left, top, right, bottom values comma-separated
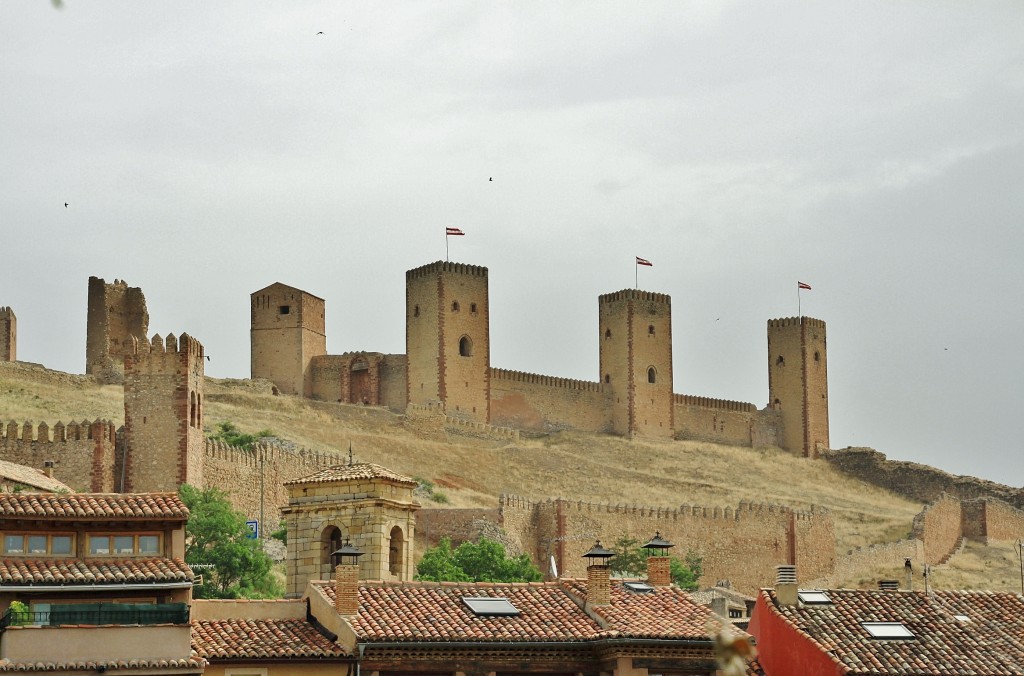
(180, 484, 283, 598)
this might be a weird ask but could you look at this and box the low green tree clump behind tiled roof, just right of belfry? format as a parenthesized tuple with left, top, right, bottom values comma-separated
(416, 538, 544, 582)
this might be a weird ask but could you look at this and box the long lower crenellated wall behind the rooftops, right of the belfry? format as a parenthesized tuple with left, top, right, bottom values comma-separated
(502, 498, 836, 594)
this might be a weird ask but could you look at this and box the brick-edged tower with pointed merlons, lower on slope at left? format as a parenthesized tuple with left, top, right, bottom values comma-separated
(124, 333, 206, 493)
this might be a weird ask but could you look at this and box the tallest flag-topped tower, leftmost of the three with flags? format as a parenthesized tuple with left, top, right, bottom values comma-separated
(406, 261, 490, 422)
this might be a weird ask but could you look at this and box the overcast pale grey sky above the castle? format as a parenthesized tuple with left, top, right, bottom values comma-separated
(0, 0, 1024, 487)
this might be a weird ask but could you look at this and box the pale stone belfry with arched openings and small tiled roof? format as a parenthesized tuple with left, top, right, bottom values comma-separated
(282, 463, 420, 597)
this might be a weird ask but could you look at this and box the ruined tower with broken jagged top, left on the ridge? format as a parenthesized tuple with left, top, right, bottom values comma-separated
(85, 277, 150, 383)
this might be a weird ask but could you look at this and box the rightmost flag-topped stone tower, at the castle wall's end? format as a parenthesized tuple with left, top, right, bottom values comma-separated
(768, 316, 828, 458)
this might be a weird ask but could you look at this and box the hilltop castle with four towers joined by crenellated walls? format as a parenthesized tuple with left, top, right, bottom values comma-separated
(251, 261, 828, 457)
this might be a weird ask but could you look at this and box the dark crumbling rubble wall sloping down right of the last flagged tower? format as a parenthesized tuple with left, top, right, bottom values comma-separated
(821, 448, 1024, 509)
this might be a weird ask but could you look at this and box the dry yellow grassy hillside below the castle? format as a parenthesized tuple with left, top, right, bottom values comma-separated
(0, 364, 1019, 591)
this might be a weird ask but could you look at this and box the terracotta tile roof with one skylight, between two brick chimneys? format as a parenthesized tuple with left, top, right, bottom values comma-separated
(314, 582, 601, 642)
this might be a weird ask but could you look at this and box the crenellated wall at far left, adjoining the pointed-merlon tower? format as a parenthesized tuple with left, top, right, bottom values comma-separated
(0, 420, 119, 493)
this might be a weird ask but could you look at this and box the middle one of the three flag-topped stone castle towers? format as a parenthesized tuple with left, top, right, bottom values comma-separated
(597, 289, 675, 438)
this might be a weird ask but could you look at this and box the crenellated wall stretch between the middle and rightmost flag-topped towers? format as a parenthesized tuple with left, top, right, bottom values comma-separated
(674, 394, 765, 447)
